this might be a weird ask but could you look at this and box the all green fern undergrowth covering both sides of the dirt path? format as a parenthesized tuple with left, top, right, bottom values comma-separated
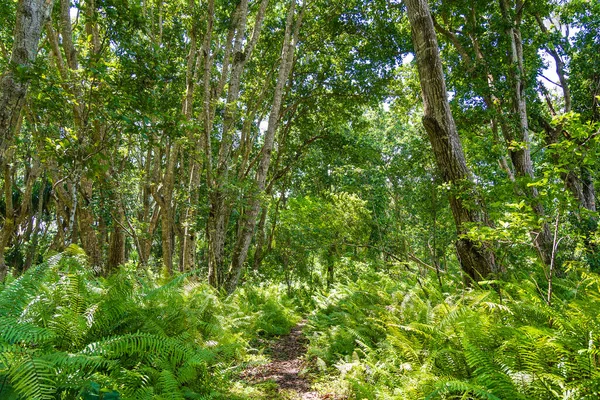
(0, 249, 600, 400)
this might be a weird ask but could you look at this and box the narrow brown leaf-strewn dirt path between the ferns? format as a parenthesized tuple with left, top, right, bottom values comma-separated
(242, 322, 335, 400)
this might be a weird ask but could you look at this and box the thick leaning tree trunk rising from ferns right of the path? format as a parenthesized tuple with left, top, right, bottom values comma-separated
(404, 0, 497, 280)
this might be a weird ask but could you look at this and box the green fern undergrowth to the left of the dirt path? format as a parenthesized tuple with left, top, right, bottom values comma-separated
(0, 251, 298, 400)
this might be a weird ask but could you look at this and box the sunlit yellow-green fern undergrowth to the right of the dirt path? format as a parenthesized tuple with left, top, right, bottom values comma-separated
(305, 273, 600, 400)
